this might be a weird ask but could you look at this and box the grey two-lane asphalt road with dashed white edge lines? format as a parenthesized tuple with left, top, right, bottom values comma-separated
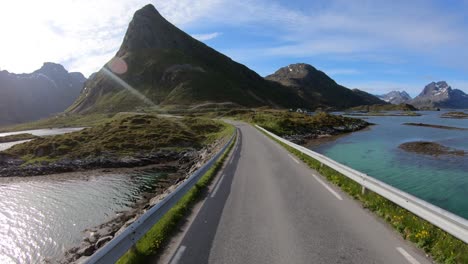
(166, 123, 430, 264)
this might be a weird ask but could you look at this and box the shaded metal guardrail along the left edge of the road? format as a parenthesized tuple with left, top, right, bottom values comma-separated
(86, 129, 237, 264)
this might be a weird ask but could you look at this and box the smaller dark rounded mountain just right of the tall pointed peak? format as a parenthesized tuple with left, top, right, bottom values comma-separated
(266, 63, 385, 109)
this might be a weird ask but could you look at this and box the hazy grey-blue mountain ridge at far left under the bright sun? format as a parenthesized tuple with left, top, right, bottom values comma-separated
(0, 62, 86, 125)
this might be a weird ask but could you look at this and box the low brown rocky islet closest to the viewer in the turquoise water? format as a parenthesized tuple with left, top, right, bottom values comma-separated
(399, 141, 465, 156)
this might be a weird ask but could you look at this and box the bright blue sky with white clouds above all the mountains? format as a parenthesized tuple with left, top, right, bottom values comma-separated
(0, 0, 468, 96)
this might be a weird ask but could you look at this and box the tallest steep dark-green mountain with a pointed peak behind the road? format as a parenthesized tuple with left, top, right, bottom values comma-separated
(68, 5, 305, 113)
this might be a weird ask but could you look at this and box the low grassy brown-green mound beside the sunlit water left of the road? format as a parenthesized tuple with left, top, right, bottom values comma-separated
(5, 114, 228, 163)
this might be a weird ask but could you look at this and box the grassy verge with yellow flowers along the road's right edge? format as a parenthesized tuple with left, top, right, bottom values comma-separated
(259, 127, 468, 264)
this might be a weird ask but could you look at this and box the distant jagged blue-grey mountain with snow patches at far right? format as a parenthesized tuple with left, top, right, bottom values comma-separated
(409, 81, 468, 109)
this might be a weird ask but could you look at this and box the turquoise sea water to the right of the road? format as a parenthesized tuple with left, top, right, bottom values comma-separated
(312, 112, 468, 219)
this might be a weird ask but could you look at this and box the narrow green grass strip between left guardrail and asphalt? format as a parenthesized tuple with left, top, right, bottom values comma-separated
(117, 126, 236, 264)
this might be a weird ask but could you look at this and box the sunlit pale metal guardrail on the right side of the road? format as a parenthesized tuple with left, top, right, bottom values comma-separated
(256, 126, 468, 243)
